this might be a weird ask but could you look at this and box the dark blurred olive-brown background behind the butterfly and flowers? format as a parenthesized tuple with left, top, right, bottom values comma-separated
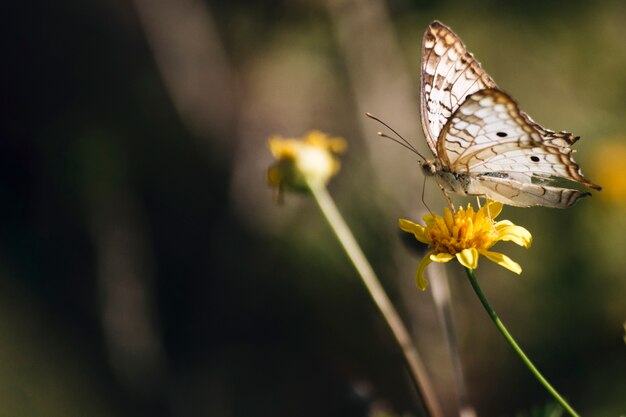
(0, 0, 626, 417)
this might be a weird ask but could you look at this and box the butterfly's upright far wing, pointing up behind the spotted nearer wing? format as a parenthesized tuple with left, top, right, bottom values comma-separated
(420, 21, 496, 156)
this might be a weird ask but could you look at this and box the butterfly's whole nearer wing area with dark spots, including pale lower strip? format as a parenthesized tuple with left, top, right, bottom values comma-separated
(437, 89, 600, 207)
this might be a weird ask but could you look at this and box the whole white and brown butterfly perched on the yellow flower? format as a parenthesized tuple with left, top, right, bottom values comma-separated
(420, 21, 601, 208)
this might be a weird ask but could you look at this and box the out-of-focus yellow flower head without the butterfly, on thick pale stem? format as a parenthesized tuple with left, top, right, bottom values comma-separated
(267, 130, 347, 198)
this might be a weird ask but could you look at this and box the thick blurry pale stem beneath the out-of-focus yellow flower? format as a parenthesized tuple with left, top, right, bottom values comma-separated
(309, 184, 443, 417)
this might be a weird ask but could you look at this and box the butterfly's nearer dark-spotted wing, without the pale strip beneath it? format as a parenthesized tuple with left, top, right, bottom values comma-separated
(438, 89, 597, 192)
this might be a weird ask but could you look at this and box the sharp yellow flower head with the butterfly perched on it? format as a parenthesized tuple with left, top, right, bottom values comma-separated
(399, 201, 532, 291)
